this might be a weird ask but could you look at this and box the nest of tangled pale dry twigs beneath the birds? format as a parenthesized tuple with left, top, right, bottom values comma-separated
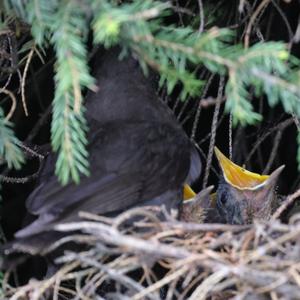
(3, 207, 300, 300)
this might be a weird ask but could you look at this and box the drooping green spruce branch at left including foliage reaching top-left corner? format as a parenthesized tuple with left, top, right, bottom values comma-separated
(4, 0, 94, 184)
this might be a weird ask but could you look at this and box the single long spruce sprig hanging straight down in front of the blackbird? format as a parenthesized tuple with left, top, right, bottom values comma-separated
(51, 2, 94, 184)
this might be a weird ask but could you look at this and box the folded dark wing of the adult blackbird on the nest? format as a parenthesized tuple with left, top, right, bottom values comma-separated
(16, 122, 190, 237)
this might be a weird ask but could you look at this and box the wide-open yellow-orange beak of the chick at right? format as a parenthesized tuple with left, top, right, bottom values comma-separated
(215, 147, 278, 190)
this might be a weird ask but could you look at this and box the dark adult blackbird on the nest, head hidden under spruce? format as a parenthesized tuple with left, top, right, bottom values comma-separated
(6, 49, 201, 254)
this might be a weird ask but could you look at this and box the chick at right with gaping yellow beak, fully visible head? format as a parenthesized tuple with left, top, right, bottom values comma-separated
(215, 147, 284, 224)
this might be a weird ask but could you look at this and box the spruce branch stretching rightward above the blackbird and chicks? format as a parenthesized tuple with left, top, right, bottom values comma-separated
(94, 1, 300, 125)
